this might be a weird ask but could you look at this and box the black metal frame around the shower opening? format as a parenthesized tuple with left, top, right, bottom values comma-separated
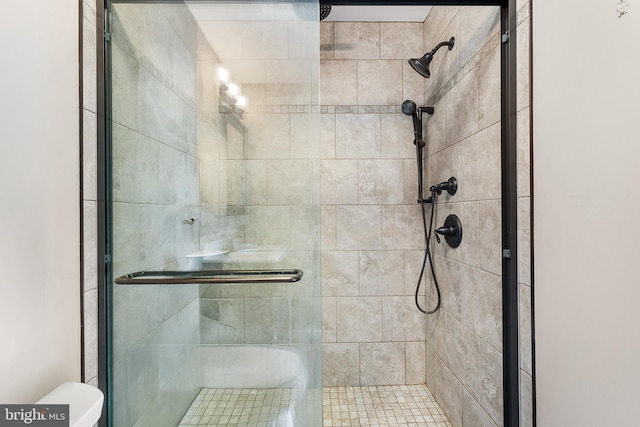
(96, 0, 524, 427)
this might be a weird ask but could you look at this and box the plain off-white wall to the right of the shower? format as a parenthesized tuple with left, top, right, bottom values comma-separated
(532, 0, 640, 427)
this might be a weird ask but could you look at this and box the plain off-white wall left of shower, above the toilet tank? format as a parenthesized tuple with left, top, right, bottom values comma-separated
(0, 0, 80, 403)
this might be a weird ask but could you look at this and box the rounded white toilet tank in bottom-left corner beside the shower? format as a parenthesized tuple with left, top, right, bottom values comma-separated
(36, 383, 104, 427)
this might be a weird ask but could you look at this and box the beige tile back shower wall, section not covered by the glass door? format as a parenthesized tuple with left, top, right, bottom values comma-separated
(320, 22, 425, 386)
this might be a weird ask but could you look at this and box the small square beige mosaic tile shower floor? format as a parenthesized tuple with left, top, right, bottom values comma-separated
(179, 385, 451, 427)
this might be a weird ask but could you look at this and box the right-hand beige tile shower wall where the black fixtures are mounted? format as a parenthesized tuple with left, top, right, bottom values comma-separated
(424, 7, 503, 427)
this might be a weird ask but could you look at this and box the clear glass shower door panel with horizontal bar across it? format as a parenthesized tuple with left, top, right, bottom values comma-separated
(106, 0, 322, 427)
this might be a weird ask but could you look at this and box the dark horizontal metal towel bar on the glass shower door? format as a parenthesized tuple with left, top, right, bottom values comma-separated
(115, 269, 303, 285)
